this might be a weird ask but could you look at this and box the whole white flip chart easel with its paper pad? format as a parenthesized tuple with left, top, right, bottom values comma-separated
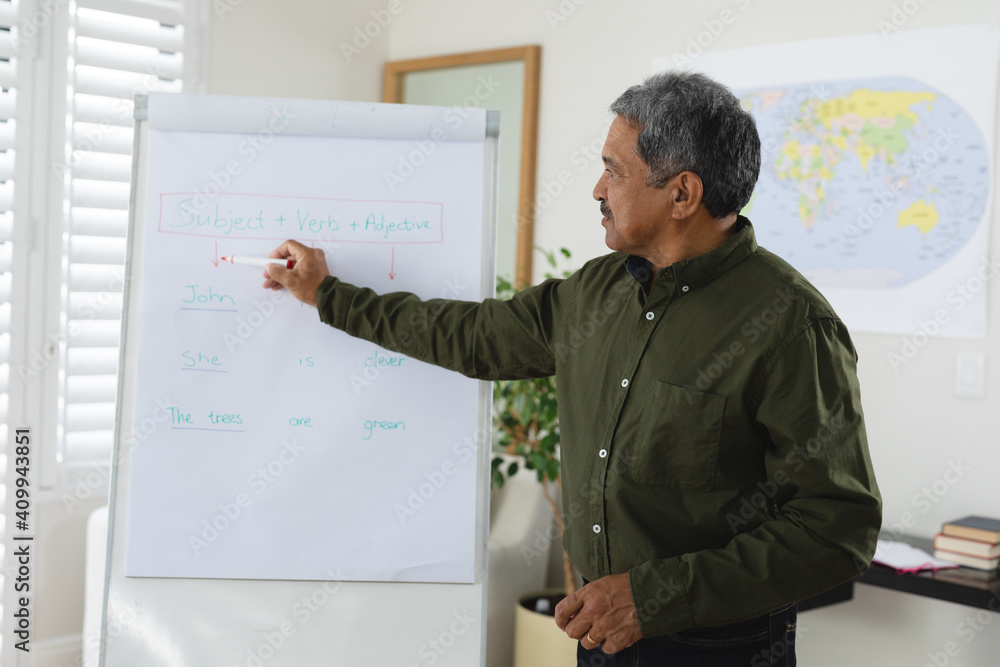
(101, 95, 499, 667)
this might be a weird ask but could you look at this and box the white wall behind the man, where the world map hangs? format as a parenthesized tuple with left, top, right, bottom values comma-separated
(389, 0, 1000, 667)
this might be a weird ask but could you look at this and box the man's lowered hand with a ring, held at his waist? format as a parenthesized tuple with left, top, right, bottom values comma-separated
(556, 573, 642, 655)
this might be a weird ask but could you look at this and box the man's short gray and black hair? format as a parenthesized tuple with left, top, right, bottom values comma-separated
(611, 72, 760, 218)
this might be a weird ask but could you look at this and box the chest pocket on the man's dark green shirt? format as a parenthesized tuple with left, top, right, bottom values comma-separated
(627, 380, 726, 491)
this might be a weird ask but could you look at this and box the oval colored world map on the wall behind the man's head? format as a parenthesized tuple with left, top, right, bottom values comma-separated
(734, 76, 990, 288)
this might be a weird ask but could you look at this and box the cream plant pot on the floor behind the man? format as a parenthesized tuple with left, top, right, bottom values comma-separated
(514, 589, 579, 667)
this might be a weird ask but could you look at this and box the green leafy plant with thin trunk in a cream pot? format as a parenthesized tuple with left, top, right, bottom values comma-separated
(491, 248, 577, 667)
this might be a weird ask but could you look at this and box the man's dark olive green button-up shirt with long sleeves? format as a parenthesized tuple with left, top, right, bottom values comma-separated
(316, 217, 881, 636)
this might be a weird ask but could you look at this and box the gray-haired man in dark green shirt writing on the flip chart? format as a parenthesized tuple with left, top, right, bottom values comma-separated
(264, 73, 881, 667)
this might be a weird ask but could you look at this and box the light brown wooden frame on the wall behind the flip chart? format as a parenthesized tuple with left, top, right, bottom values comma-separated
(382, 45, 542, 289)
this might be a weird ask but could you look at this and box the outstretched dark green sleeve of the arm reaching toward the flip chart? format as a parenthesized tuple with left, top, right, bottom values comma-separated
(316, 276, 575, 380)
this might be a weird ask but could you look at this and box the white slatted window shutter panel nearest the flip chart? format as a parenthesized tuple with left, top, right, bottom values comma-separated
(57, 0, 186, 467)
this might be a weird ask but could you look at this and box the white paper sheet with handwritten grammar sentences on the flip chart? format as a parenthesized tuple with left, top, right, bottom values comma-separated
(126, 96, 489, 582)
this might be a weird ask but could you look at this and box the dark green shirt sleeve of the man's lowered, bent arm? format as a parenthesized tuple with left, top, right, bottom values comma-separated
(630, 319, 882, 636)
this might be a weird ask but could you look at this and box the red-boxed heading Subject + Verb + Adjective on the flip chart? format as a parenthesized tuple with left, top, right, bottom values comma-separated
(159, 193, 444, 244)
